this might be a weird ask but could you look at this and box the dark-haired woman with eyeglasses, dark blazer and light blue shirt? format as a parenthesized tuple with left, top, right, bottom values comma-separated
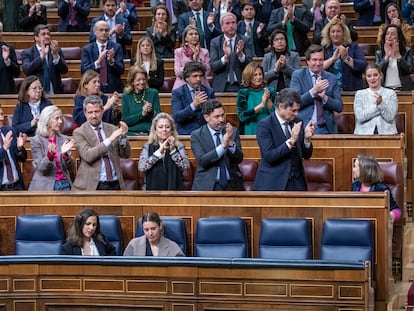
(13, 76, 52, 136)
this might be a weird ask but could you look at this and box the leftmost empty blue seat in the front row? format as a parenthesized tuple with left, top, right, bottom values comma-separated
(15, 215, 65, 255)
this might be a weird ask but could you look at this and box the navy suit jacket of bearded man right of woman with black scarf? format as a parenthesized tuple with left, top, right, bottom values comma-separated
(191, 124, 244, 191)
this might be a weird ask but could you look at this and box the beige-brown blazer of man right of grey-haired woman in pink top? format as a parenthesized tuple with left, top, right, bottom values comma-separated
(72, 122, 131, 190)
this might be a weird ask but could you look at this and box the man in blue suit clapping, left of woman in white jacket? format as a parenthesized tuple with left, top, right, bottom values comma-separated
(290, 44, 342, 134)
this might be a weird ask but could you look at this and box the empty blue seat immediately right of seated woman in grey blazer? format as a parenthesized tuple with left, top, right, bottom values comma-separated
(195, 217, 248, 258)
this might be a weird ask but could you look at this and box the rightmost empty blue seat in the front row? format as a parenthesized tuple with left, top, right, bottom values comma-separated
(320, 219, 375, 266)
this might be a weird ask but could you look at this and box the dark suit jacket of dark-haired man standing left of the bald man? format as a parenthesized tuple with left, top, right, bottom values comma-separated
(22, 46, 68, 93)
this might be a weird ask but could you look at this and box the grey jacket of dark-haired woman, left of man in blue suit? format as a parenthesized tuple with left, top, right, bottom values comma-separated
(262, 51, 301, 90)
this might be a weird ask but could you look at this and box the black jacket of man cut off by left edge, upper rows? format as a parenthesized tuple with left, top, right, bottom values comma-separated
(0, 41, 20, 94)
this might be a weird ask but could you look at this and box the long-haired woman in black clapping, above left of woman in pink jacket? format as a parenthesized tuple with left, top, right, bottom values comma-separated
(146, 4, 176, 58)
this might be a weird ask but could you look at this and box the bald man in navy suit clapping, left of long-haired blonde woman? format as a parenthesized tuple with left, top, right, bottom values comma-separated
(81, 21, 124, 93)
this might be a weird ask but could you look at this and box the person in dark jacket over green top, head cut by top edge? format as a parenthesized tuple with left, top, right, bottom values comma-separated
(266, 0, 312, 56)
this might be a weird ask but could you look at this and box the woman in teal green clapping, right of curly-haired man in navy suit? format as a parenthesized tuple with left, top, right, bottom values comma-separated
(236, 62, 276, 135)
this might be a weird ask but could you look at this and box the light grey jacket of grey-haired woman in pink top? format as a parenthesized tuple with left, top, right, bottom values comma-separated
(29, 135, 75, 190)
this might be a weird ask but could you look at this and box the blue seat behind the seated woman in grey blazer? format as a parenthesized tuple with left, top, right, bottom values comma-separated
(135, 217, 187, 254)
